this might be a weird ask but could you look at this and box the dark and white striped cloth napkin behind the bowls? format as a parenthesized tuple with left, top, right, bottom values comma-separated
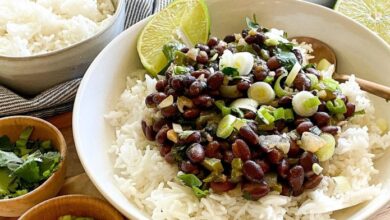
(0, 0, 334, 118)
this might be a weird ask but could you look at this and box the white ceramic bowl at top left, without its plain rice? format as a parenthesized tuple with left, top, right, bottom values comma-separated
(0, 0, 125, 96)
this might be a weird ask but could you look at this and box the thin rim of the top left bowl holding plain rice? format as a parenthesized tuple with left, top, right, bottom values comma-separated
(0, 0, 125, 61)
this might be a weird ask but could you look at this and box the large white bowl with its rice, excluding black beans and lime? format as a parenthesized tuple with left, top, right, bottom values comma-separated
(73, 0, 390, 219)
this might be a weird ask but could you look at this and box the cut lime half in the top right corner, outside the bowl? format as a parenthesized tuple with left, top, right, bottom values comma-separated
(334, 0, 390, 44)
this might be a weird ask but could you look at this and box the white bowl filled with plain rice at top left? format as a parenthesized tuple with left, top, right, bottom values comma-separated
(0, 0, 125, 95)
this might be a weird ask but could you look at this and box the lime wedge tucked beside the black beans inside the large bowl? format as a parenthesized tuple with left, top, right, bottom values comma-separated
(137, 0, 210, 76)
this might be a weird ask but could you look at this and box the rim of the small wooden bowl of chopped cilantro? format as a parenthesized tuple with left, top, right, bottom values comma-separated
(0, 116, 67, 205)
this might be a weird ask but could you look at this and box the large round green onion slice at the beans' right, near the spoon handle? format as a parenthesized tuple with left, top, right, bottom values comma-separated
(292, 91, 318, 117)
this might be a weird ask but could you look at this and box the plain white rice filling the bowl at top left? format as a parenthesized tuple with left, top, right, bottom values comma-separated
(0, 0, 115, 56)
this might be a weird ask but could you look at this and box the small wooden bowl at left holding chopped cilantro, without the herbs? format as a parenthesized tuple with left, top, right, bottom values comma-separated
(0, 116, 66, 217)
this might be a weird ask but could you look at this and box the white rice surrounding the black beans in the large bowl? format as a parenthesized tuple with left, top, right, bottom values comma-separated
(107, 74, 390, 219)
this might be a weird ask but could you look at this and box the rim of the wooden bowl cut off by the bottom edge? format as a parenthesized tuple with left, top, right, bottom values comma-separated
(18, 194, 123, 219)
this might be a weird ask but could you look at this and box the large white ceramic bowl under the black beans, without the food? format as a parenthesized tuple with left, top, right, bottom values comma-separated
(73, 0, 390, 219)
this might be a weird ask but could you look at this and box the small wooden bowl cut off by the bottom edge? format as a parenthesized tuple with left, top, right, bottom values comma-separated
(19, 195, 124, 220)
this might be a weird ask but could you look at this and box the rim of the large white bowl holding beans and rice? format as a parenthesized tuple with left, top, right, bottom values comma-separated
(72, 0, 390, 219)
